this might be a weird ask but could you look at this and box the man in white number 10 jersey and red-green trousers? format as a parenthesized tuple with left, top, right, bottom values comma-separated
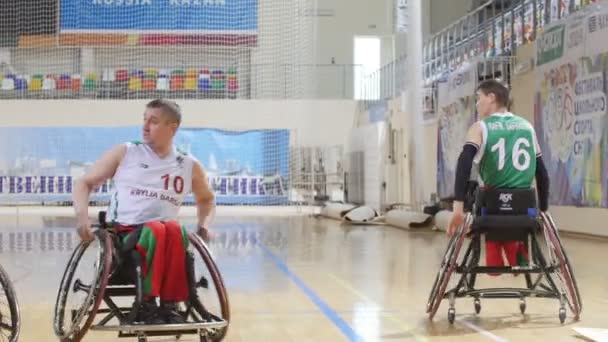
(73, 100, 214, 324)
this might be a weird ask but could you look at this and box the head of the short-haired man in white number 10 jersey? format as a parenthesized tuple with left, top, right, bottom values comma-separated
(143, 100, 182, 146)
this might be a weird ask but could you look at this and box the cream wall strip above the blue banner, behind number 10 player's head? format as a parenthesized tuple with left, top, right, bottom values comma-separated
(0, 100, 356, 146)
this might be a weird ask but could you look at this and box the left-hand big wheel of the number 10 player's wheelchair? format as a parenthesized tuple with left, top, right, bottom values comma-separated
(53, 230, 112, 342)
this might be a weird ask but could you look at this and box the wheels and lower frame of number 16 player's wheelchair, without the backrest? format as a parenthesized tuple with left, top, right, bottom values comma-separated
(426, 199, 582, 324)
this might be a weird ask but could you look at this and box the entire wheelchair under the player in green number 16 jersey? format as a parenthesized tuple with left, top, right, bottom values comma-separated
(426, 182, 582, 324)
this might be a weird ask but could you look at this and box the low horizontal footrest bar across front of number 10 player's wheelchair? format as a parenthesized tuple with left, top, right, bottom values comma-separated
(91, 320, 228, 336)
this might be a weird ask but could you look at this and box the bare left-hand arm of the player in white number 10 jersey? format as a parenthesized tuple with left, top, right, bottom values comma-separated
(72, 144, 127, 241)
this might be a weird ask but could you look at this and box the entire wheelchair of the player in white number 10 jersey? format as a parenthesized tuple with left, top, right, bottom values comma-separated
(53, 212, 230, 342)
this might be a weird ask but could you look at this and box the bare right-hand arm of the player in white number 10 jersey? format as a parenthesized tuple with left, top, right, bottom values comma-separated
(192, 162, 215, 240)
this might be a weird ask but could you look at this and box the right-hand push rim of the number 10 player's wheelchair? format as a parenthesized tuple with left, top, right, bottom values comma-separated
(188, 232, 230, 341)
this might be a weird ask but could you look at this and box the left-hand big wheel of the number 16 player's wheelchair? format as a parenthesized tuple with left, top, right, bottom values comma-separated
(426, 214, 472, 320)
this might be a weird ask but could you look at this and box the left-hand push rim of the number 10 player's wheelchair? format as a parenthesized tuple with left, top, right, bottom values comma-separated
(53, 230, 112, 341)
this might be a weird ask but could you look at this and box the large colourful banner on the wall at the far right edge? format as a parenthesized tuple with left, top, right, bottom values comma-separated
(535, 8, 608, 207)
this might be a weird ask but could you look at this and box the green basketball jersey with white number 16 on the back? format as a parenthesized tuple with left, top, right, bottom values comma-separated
(478, 113, 536, 188)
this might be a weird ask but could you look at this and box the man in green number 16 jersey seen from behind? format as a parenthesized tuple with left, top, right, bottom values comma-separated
(448, 80, 549, 272)
